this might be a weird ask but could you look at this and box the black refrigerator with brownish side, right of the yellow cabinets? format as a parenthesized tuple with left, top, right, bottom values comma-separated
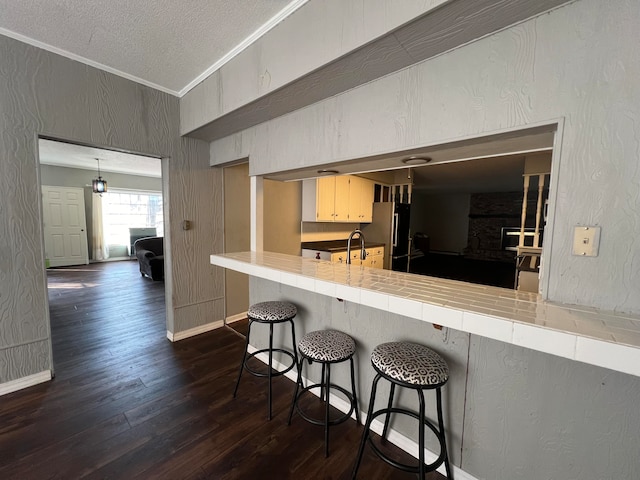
(362, 202, 411, 272)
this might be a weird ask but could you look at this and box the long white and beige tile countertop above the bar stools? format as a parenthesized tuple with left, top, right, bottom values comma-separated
(211, 252, 640, 377)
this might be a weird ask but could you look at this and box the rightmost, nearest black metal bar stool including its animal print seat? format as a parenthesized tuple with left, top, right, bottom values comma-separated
(352, 342, 453, 479)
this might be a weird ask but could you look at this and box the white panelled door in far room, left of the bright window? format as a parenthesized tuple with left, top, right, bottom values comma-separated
(42, 185, 89, 267)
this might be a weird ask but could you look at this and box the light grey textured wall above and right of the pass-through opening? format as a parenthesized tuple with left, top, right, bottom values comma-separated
(211, 0, 640, 313)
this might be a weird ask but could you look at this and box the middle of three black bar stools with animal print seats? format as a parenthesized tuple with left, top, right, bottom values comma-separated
(287, 330, 360, 457)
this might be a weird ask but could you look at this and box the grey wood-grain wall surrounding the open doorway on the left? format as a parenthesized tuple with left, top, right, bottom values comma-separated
(0, 36, 222, 383)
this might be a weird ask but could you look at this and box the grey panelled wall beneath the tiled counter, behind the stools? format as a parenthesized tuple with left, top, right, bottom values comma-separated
(250, 278, 640, 480)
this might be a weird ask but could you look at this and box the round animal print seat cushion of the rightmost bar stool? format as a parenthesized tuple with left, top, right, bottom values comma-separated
(371, 342, 449, 386)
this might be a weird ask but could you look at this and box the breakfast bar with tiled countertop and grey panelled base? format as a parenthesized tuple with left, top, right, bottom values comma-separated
(210, 252, 640, 480)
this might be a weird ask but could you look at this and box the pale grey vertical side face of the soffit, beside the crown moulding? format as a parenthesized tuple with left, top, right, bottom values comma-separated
(180, 0, 446, 133)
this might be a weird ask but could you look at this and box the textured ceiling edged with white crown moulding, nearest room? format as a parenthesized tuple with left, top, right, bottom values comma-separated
(0, 0, 306, 95)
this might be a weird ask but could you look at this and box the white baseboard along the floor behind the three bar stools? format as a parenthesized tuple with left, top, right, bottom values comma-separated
(248, 345, 478, 480)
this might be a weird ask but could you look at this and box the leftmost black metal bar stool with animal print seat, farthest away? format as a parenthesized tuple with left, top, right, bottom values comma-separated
(233, 301, 298, 420)
